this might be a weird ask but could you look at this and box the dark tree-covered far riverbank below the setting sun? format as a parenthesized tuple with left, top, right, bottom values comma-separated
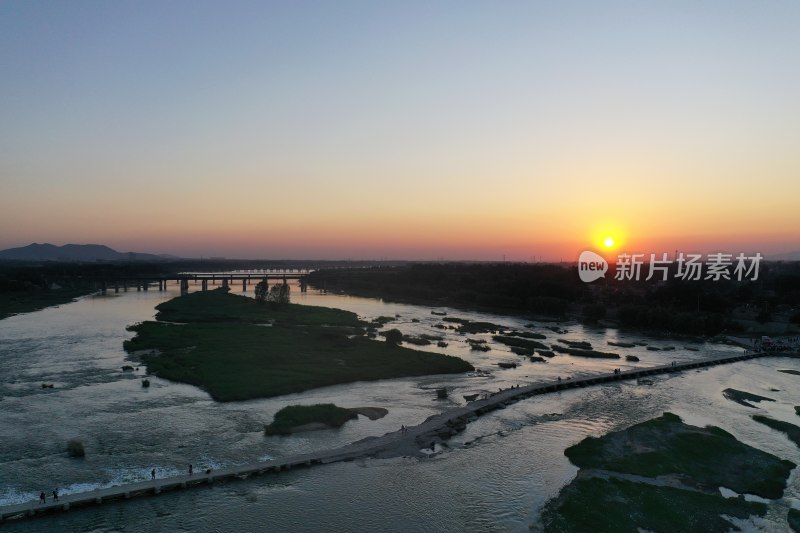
(306, 263, 800, 338)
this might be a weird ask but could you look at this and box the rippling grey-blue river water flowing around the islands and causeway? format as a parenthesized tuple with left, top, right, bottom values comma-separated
(0, 280, 800, 532)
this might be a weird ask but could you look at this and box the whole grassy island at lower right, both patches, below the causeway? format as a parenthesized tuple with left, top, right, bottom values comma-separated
(542, 413, 795, 532)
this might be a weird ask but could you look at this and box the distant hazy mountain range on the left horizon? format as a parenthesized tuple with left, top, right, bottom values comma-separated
(0, 243, 178, 262)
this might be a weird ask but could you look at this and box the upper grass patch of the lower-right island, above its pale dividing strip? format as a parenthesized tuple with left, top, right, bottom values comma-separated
(564, 413, 795, 499)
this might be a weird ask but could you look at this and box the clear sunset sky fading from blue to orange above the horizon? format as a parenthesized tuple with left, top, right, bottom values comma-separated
(0, 0, 800, 261)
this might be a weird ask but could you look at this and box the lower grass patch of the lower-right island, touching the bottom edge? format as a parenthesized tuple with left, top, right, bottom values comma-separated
(541, 478, 767, 533)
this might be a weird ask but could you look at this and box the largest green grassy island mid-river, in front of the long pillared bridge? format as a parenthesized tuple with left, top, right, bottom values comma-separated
(125, 290, 473, 401)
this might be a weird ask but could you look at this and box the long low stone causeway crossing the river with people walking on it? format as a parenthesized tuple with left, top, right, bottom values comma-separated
(0, 351, 798, 522)
